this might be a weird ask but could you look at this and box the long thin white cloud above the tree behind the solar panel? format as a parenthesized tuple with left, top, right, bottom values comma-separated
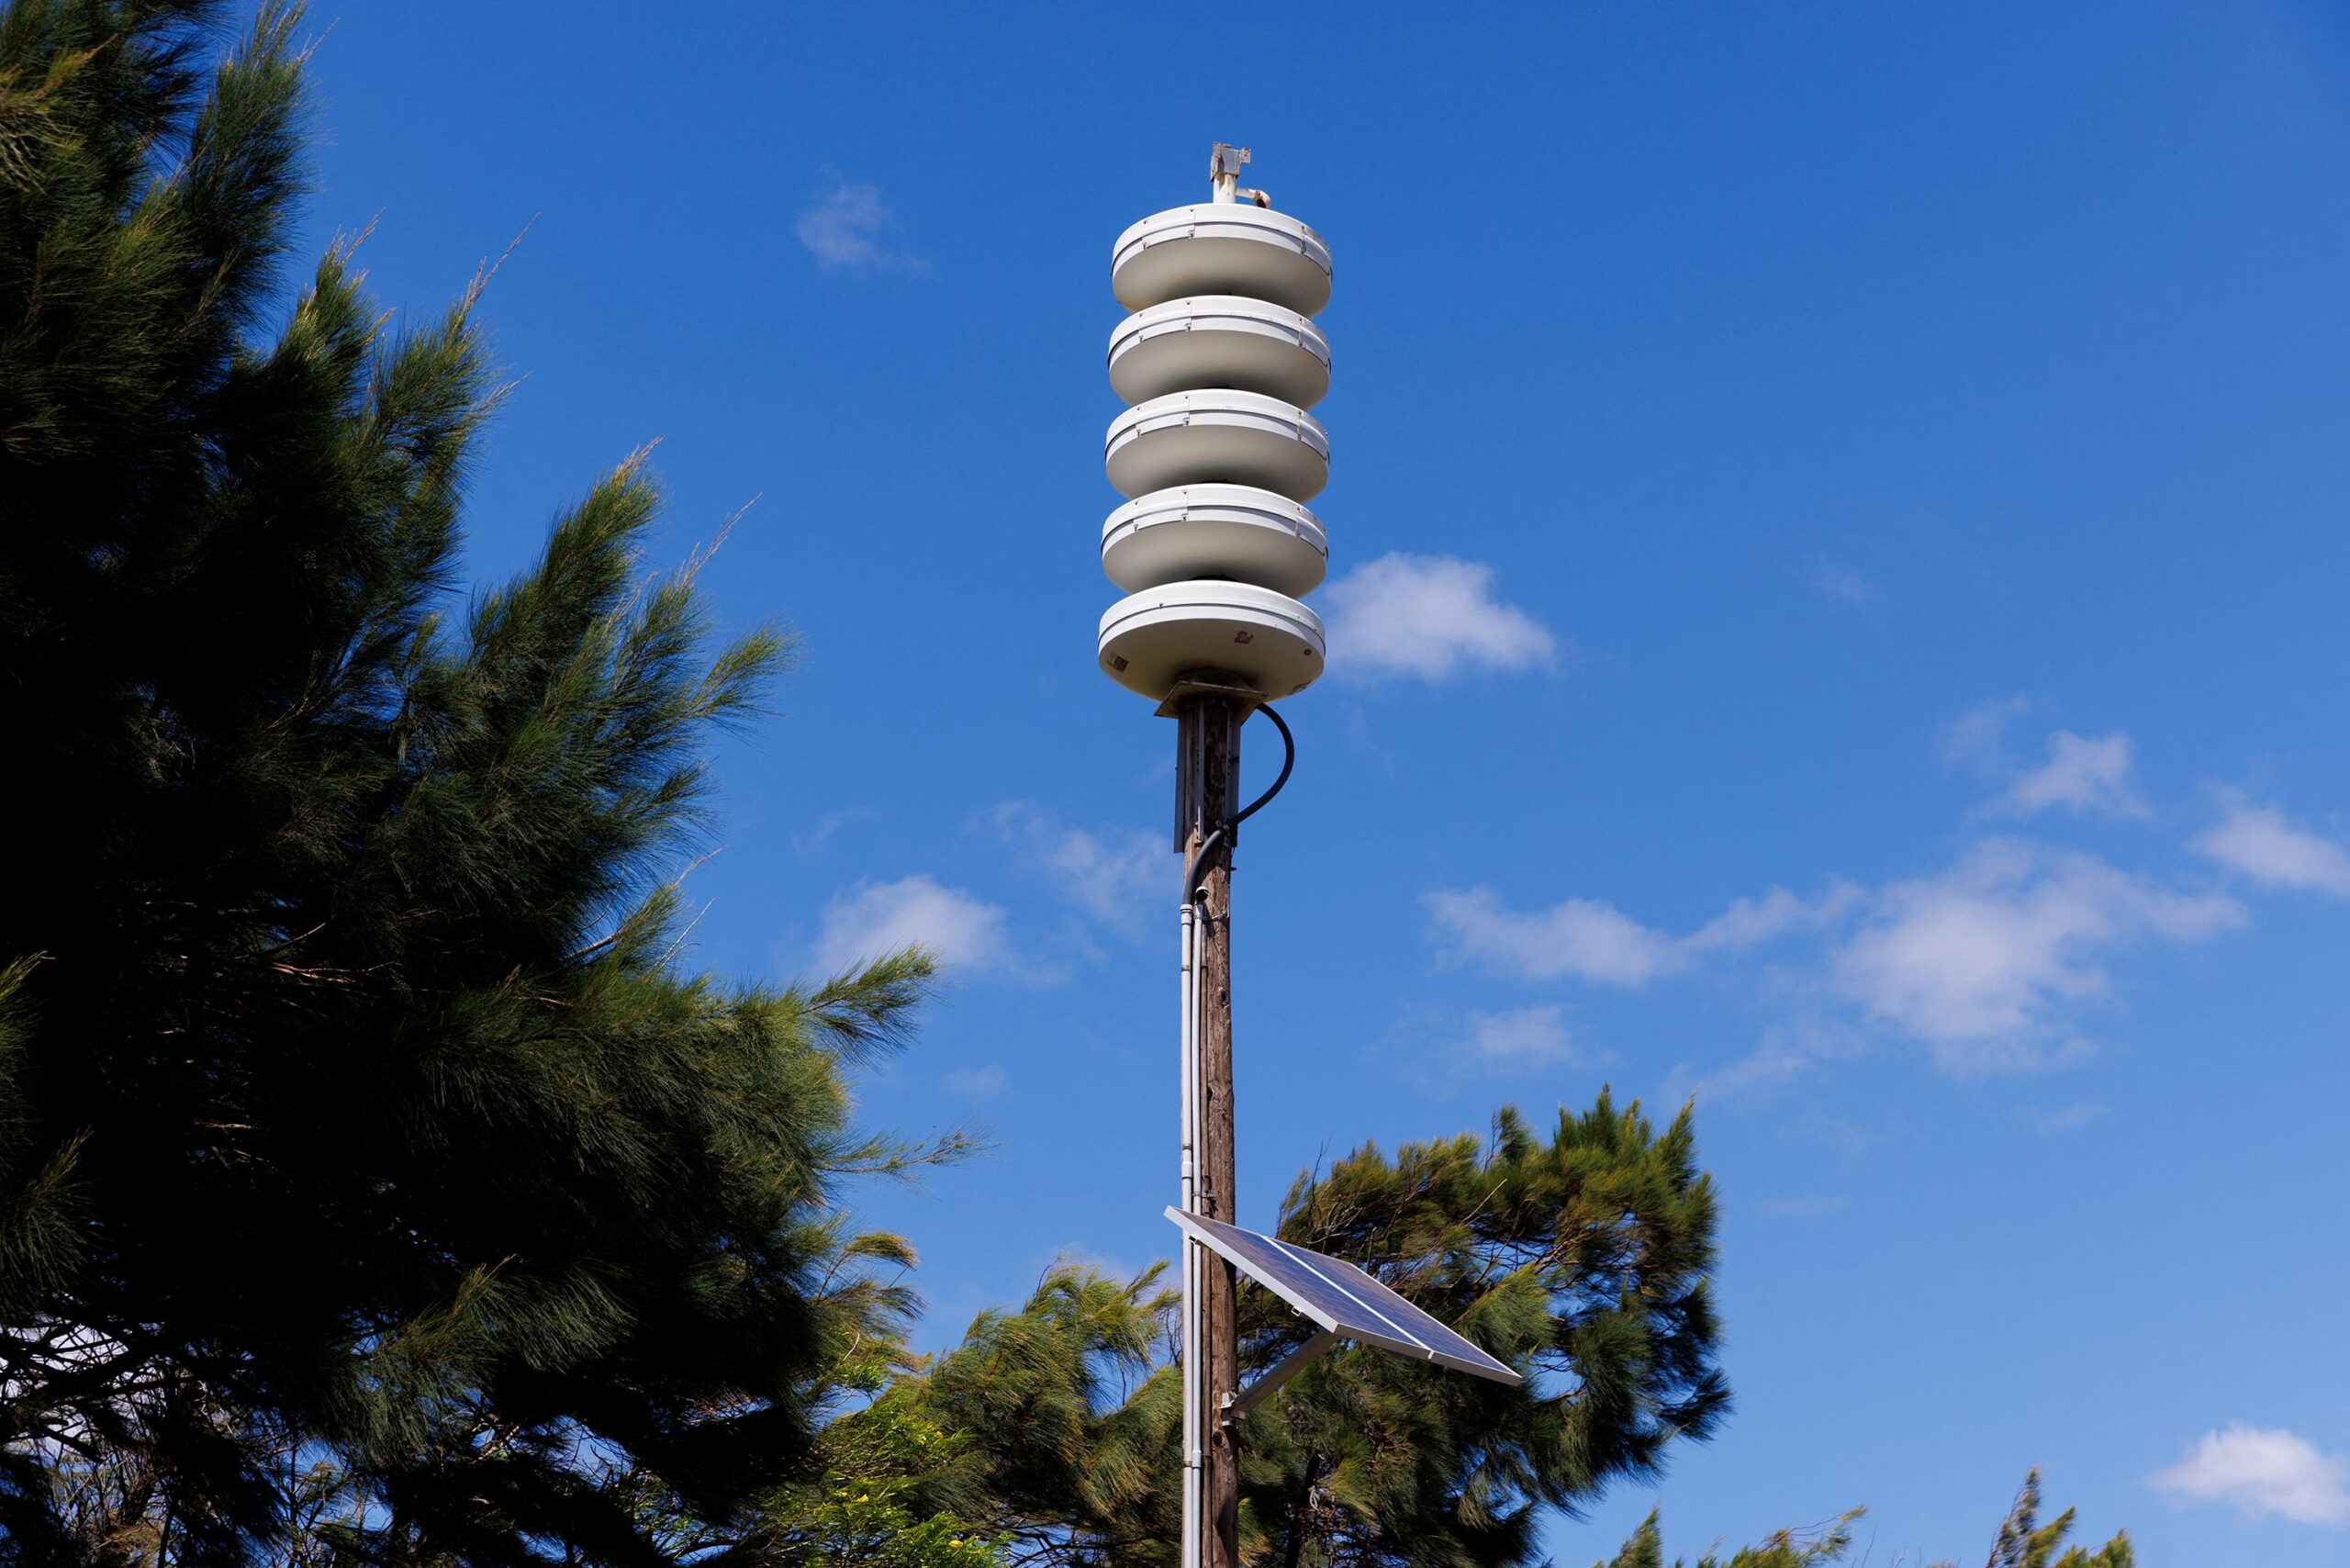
(1427, 881, 1862, 985)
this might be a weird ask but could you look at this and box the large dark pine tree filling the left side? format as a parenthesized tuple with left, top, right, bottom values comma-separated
(0, 0, 954, 1563)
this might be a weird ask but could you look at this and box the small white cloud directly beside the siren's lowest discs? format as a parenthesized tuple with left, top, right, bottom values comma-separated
(1321, 554, 1558, 684)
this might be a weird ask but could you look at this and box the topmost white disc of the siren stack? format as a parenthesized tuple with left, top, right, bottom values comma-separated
(1109, 202, 1330, 315)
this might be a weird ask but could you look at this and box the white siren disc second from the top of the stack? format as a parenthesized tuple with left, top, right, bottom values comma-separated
(1109, 294, 1330, 409)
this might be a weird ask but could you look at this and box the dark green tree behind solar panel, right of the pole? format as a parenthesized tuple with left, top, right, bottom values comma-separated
(1241, 1093, 1729, 1568)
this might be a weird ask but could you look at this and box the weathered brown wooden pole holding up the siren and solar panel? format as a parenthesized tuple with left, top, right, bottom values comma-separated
(1172, 689, 1252, 1568)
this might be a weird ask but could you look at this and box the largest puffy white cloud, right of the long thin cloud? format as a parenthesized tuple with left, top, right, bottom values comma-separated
(1833, 839, 2244, 1068)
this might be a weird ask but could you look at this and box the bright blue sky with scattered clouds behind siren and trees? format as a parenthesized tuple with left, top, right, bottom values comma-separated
(294, 0, 2350, 1568)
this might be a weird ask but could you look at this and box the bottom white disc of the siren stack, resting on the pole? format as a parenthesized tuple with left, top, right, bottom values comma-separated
(1095, 583, 1323, 700)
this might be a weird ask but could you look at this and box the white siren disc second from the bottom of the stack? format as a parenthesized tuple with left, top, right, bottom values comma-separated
(1102, 485, 1330, 599)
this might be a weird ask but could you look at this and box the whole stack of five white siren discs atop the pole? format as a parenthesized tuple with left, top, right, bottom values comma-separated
(1098, 143, 1330, 700)
